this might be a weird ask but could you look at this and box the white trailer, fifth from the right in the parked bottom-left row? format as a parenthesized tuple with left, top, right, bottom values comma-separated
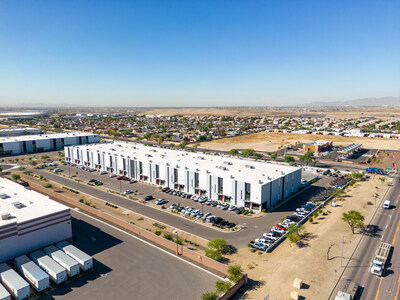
(0, 263, 30, 300)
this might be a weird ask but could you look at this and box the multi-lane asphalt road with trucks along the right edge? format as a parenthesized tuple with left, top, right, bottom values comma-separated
(331, 178, 400, 300)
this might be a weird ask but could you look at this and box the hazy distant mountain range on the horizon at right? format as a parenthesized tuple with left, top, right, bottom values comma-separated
(304, 97, 400, 107)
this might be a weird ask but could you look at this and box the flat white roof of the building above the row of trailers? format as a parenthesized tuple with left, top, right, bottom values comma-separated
(0, 178, 69, 227)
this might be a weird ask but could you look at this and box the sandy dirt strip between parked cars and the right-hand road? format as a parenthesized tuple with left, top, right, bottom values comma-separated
(230, 177, 388, 300)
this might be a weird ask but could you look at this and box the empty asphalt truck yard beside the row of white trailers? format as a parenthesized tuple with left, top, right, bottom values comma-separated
(39, 210, 220, 300)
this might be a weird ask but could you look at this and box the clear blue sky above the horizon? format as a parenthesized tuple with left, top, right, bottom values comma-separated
(0, 0, 400, 106)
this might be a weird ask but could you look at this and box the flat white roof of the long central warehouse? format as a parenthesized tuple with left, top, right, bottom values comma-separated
(71, 142, 300, 184)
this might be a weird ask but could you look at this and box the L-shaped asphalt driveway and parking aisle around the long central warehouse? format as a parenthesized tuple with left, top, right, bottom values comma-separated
(33, 166, 331, 248)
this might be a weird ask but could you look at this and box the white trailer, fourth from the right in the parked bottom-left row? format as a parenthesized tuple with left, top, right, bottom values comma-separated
(14, 255, 50, 292)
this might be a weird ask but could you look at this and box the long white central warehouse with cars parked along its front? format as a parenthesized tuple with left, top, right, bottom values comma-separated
(65, 142, 301, 210)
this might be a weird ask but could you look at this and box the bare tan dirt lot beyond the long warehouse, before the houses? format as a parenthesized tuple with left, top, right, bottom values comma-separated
(199, 132, 400, 152)
